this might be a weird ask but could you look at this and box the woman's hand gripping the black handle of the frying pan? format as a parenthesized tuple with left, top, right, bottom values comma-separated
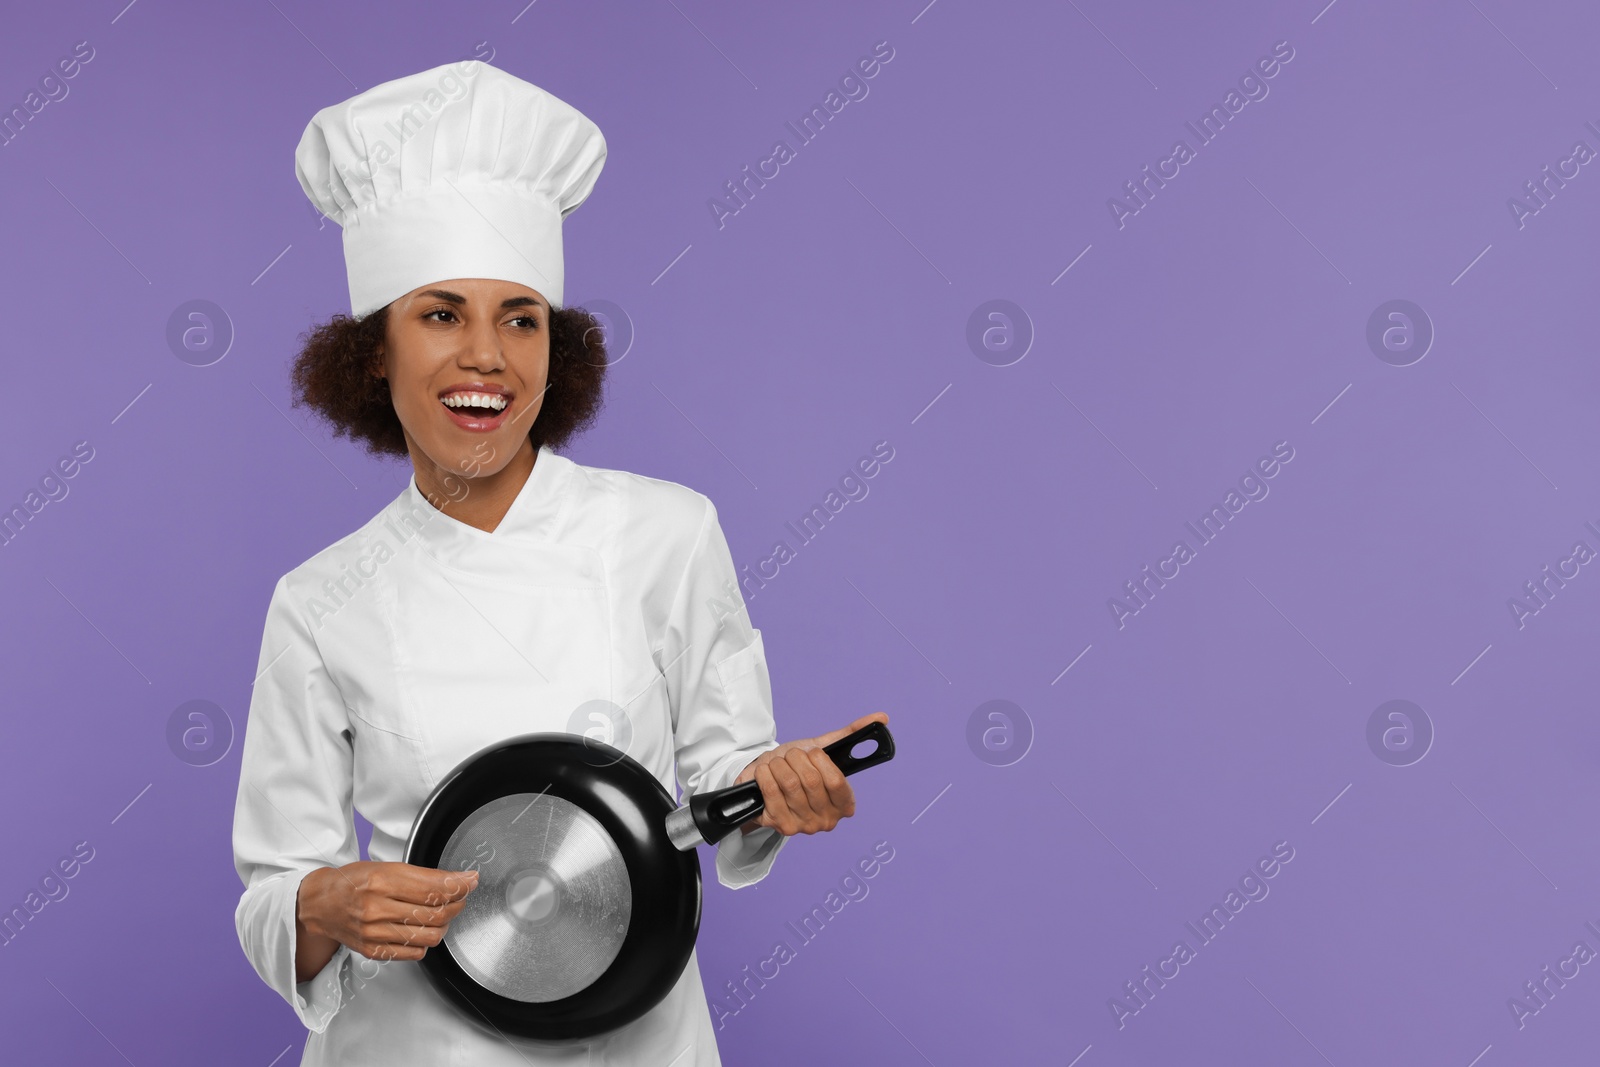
(734, 712, 890, 837)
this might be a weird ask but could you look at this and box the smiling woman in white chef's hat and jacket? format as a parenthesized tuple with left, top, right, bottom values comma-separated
(234, 61, 886, 1067)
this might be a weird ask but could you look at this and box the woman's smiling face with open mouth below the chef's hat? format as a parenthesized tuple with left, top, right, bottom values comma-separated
(379, 278, 550, 486)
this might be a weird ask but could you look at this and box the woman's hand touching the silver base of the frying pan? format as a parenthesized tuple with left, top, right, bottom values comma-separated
(294, 861, 478, 982)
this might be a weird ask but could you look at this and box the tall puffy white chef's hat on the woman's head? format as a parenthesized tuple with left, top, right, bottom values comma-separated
(294, 59, 606, 318)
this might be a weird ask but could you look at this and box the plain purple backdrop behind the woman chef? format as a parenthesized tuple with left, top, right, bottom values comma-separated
(0, 0, 1600, 1067)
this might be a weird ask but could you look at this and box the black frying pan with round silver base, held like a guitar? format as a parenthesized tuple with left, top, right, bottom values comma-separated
(405, 723, 894, 1041)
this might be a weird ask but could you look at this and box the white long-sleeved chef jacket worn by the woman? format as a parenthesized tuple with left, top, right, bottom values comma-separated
(234, 448, 787, 1067)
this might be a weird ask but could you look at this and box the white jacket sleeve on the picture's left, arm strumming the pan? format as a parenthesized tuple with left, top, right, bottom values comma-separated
(234, 576, 360, 1033)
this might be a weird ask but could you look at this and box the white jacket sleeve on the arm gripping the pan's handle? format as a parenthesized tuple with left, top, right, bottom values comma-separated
(661, 498, 789, 889)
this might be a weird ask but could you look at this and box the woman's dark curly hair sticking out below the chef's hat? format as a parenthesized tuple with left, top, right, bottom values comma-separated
(291, 306, 606, 456)
